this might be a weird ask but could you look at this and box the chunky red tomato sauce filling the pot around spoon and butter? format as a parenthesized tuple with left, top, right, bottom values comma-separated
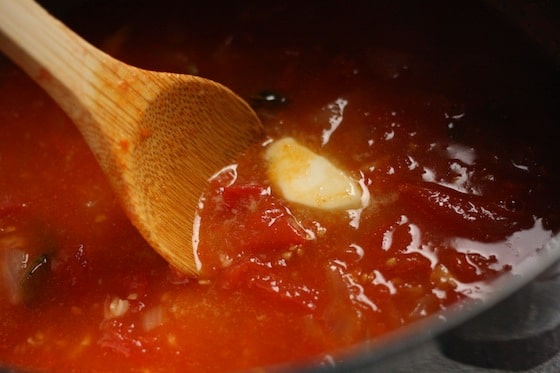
(0, 1, 560, 372)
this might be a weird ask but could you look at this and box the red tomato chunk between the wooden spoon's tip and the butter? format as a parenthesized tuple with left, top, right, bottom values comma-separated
(198, 184, 313, 275)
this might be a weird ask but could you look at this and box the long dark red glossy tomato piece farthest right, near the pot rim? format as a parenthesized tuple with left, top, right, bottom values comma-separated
(398, 183, 533, 242)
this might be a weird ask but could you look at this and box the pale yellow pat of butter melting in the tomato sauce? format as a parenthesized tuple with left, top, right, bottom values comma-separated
(265, 137, 363, 210)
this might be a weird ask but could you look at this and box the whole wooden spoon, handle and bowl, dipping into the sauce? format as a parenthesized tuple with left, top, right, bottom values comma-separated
(0, 0, 262, 276)
